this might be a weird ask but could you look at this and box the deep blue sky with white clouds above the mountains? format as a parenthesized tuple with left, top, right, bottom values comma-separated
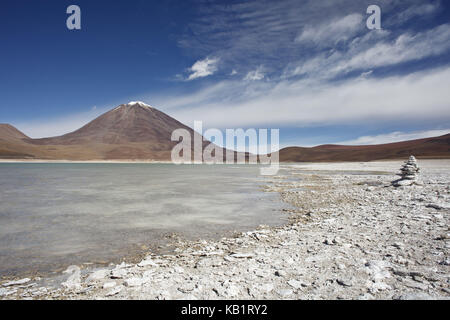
(0, 0, 450, 146)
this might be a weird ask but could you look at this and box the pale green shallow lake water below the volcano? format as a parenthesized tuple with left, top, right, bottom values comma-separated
(0, 163, 283, 276)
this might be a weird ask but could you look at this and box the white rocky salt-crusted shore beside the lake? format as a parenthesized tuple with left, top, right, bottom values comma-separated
(0, 159, 450, 299)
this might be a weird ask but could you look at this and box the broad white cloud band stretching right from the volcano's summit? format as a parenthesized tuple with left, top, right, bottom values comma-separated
(160, 67, 450, 128)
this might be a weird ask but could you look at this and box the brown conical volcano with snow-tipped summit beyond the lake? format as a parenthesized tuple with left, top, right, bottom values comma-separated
(0, 102, 216, 160)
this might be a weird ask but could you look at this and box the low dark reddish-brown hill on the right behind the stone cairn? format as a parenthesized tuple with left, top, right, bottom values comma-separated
(280, 134, 450, 162)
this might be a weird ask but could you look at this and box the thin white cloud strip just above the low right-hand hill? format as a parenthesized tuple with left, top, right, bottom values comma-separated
(338, 128, 450, 145)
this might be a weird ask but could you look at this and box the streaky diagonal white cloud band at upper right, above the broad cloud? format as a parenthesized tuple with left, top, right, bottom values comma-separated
(283, 24, 450, 81)
